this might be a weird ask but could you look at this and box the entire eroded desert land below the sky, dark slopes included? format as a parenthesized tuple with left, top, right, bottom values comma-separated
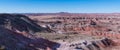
(0, 12, 120, 50)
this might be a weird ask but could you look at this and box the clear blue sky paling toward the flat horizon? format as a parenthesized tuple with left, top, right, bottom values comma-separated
(0, 0, 120, 13)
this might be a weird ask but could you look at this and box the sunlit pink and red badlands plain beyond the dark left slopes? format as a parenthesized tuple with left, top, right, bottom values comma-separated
(26, 12, 120, 50)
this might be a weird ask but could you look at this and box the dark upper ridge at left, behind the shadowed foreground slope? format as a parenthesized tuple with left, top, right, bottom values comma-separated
(0, 14, 51, 33)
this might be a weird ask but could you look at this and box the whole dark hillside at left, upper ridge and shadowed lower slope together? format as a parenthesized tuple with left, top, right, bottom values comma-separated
(0, 14, 60, 50)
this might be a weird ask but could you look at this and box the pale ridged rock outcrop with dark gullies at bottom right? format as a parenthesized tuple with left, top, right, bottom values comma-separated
(58, 38, 115, 50)
